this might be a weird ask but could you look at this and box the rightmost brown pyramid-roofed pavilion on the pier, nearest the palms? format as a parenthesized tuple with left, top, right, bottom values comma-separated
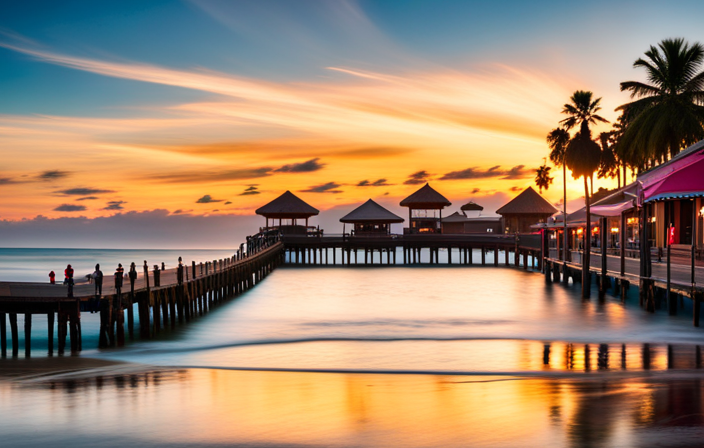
(496, 187, 557, 233)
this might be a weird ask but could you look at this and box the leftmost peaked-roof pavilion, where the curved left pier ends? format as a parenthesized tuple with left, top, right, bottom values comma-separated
(256, 191, 320, 235)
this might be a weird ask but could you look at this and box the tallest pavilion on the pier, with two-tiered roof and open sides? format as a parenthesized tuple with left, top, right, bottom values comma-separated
(401, 184, 452, 233)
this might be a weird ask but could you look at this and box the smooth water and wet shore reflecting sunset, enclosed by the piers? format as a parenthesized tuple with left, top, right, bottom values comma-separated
(0, 251, 704, 447)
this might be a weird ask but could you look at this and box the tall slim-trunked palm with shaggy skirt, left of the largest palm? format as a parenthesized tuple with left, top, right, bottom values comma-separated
(561, 90, 608, 298)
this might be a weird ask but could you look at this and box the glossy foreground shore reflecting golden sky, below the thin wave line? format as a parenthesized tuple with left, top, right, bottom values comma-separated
(0, 368, 704, 447)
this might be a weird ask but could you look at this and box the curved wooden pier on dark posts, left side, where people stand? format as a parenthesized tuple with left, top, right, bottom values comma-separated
(0, 238, 284, 358)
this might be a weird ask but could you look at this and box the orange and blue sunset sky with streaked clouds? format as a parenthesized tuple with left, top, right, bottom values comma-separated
(0, 0, 704, 247)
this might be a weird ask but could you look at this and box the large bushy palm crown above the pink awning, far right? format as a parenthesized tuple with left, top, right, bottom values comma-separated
(616, 38, 704, 163)
